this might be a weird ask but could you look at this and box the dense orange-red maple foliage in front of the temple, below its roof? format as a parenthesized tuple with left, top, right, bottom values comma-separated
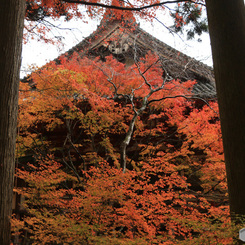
(13, 53, 233, 244)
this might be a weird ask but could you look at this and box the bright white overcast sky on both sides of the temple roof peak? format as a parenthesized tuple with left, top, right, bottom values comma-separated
(21, 8, 212, 78)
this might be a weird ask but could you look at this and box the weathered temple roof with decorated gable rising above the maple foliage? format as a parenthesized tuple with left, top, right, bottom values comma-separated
(62, 10, 216, 98)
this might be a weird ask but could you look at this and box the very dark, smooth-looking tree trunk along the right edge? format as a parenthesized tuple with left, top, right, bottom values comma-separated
(206, 0, 245, 215)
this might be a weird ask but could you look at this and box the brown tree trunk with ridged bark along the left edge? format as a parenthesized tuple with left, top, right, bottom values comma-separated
(0, 0, 25, 245)
